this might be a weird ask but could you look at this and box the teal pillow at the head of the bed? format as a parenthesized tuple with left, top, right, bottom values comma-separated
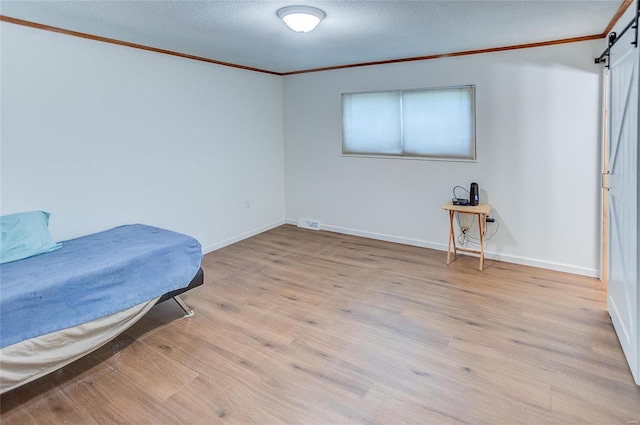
(0, 211, 62, 264)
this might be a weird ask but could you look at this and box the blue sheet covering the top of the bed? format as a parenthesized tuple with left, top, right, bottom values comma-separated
(0, 224, 202, 348)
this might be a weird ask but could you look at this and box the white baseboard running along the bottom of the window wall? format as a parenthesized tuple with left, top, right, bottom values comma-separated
(286, 219, 600, 278)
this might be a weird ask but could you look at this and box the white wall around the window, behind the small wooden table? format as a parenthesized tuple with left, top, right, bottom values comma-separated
(284, 41, 602, 276)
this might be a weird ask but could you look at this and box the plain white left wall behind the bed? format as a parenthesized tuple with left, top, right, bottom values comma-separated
(0, 23, 285, 251)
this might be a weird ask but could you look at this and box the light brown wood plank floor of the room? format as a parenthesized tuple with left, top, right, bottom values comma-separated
(0, 226, 640, 425)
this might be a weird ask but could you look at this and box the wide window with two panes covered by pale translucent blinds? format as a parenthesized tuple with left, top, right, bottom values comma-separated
(342, 86, 476, 160)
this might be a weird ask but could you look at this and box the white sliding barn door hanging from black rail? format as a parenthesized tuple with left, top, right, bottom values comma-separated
(607, 25, 640, 385)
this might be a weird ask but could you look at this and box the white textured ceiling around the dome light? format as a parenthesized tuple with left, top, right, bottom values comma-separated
(0, 0, 622, 73)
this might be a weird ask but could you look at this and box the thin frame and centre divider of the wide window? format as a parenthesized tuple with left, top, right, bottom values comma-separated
(340, 84, 478, 163)
